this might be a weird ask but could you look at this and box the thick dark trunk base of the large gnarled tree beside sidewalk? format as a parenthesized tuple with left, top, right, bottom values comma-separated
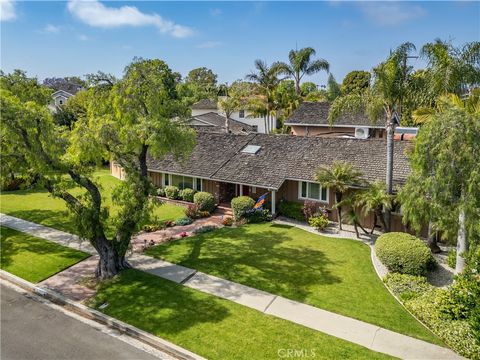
(95, 239, 131, 280)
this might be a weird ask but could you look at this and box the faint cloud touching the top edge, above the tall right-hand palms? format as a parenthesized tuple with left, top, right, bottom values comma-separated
(357, 2, 426, 26)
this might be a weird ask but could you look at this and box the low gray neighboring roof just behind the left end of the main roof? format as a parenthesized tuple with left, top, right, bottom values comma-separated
(187, 112, 257, 134)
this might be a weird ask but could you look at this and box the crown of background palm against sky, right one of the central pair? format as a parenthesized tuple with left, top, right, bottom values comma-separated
(275, 47, 330, 95)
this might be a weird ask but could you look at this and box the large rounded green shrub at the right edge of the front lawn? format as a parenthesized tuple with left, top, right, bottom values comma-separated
(375, 232, 435, 275)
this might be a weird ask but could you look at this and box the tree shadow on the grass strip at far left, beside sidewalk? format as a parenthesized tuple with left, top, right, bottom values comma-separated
(0, 226, 86, 267)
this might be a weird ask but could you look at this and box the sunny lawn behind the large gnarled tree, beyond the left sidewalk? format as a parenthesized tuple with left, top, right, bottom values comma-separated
(0, 169, 185, 235)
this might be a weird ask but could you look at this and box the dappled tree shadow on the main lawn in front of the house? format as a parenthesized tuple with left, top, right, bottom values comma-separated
(149, 224, 342, 301)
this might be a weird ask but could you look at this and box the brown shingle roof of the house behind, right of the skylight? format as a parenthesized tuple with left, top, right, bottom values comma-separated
(285, 101, 383, 127)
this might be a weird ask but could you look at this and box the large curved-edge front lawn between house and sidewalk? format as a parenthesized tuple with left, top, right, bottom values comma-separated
(147, 223, 441, 344)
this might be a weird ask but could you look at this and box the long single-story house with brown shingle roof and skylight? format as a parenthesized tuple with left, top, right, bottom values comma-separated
(111, 132, 410, 231)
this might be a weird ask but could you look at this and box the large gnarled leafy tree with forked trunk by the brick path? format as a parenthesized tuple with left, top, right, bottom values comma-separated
(0, 59, 194, 279)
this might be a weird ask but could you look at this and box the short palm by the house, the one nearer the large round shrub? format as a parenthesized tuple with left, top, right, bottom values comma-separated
(355, 181, 392, 234)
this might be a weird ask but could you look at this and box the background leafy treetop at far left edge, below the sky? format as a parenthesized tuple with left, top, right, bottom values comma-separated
(0, 69, 53, 105)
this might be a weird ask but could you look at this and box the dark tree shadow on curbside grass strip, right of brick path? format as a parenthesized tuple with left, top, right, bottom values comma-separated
(93, 269, 230, 335)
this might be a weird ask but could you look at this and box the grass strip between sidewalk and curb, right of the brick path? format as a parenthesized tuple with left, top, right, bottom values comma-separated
(90, 270, 390, 360)
